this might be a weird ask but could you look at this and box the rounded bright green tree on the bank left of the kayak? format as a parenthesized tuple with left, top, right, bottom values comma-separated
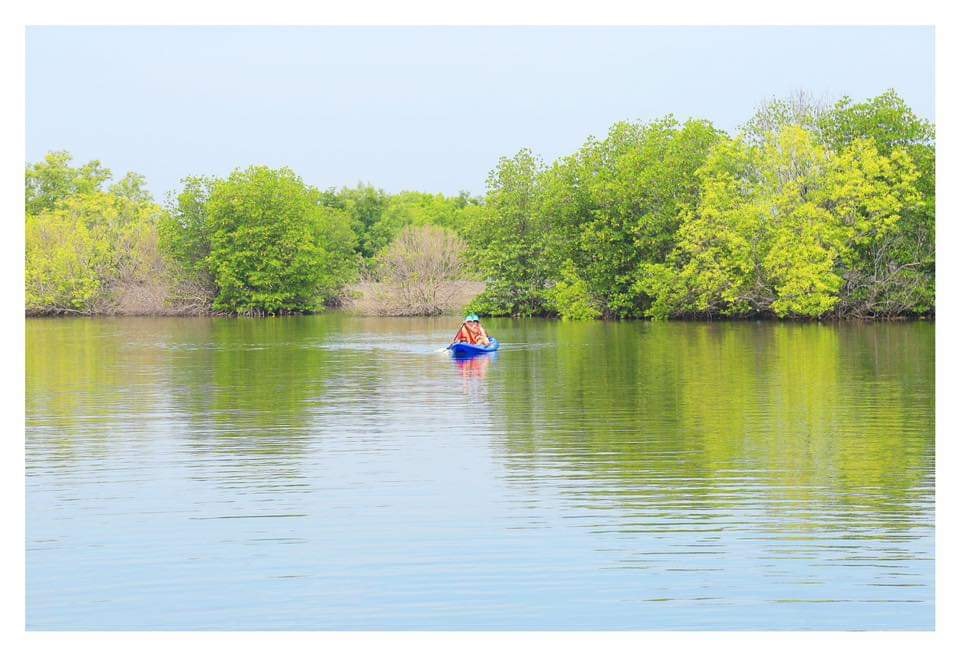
(206, 166, 355, 314)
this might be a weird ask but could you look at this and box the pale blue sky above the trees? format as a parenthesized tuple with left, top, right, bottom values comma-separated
(26, 27, 935, 200)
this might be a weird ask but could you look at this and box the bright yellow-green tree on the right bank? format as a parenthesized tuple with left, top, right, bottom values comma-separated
(644, 126, 916, 317)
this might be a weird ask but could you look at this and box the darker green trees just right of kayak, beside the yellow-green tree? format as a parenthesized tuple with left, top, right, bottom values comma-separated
(467, 117, 723, 317)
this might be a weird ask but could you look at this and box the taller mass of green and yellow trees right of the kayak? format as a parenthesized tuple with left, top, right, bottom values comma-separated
(468, 91, 935, 318)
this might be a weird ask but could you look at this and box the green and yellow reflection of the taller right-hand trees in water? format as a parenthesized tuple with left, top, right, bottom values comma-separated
(495, 323, 933, 520)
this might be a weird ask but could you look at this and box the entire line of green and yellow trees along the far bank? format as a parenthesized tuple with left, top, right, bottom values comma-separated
(25, 91, 935, 319)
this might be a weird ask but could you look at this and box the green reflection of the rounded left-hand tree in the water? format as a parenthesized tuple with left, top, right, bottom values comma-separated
(167, 319, 330, 489)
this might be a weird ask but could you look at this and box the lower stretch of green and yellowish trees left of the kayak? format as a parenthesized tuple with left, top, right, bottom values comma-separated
(25, 158, 480, 315)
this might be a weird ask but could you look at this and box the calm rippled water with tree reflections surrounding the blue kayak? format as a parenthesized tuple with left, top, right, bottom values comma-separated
(26, 314, 934, 629)
